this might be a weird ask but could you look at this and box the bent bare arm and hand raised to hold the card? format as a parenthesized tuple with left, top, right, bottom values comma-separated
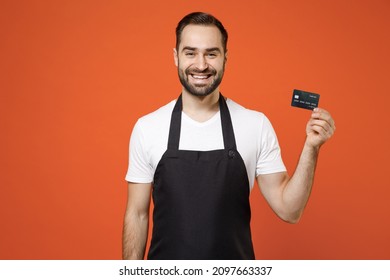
(257, 109, 336, 223)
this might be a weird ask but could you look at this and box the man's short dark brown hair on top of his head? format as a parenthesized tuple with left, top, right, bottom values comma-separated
(176, 12, 228, 52)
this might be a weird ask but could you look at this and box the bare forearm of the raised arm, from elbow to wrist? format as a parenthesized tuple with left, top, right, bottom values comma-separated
(283, 143, 319, 222)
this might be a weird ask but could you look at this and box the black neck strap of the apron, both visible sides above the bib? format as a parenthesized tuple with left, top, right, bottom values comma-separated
(168, 93, 237, 150)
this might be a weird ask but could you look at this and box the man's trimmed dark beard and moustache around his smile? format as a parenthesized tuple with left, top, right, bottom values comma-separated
(178, 64, 225, 97)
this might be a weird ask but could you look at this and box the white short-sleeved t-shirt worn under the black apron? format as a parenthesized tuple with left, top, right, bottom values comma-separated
(126, 99, 286, 189)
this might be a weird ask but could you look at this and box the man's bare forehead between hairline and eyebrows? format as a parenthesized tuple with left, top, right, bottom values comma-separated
(179, 24, 223, 50)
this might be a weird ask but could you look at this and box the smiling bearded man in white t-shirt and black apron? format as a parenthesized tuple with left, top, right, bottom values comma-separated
(123, 13, 335, 259)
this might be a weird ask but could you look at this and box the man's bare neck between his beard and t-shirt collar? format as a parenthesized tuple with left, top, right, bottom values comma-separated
(182, 89, 219, 122)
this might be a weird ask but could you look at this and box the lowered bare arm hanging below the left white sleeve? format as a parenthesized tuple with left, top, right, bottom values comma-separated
(122, 183, 152, 260)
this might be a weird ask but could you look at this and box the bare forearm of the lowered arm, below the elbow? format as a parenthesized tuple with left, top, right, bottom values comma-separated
(122, 212, 149, 260)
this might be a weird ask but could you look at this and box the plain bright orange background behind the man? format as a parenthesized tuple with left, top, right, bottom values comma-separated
(0, 0, 390, 259)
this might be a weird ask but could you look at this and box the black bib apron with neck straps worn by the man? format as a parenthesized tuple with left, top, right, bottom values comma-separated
(148, 94, 255, 260)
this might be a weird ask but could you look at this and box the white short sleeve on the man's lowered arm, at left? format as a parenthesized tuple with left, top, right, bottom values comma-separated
(126, 120, 153, 183)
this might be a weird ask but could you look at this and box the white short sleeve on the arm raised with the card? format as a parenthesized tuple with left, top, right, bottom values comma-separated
(256, 116, 286, 177)
